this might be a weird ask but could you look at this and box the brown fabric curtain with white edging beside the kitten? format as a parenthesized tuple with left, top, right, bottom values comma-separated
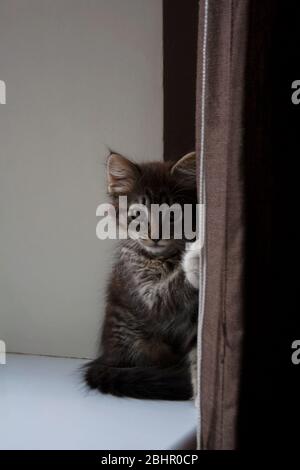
(196, 0, 249, 449)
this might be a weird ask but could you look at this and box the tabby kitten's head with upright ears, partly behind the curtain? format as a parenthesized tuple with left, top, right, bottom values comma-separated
(107, 152, 197, 256)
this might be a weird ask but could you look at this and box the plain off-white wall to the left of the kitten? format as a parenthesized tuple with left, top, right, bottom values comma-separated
(0, 0, 163, 357)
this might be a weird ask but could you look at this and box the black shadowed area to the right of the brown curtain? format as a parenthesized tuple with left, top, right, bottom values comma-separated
(238, 0, 300, 450)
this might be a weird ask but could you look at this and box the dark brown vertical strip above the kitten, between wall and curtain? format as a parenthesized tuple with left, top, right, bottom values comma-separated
(163, 0, 199, 160)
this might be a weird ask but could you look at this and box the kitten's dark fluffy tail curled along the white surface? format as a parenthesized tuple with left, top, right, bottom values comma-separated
(84, 357, 193, 400)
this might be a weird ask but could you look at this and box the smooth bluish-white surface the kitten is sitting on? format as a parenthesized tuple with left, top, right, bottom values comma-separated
(0, 355, 196, 450)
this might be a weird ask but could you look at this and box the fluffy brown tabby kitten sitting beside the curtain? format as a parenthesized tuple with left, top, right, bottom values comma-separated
(85, 153, 199, 400)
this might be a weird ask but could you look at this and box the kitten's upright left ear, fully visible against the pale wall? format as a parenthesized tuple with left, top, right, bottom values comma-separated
(107, 153, 139, 195)
